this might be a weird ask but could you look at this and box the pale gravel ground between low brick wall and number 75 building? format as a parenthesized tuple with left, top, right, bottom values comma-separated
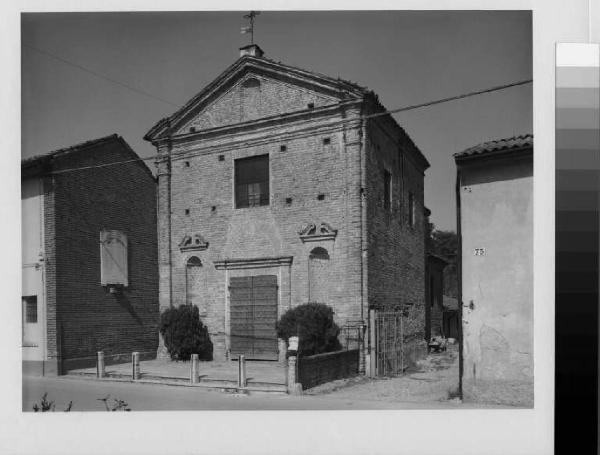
(304, 345, 458, 403)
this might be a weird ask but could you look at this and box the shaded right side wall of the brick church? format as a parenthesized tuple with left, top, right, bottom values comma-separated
(367, 117, 425, 338)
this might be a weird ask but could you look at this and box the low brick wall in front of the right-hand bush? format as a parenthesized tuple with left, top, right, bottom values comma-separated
(297, 349, 359, 390)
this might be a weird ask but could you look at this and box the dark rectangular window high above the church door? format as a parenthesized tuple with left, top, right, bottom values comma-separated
(235, 155, 269, 209)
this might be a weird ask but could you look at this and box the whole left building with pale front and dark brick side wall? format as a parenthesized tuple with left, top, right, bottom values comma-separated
(21, 135, 158, 375)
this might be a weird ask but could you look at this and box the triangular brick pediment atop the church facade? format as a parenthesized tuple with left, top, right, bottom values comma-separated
(146, 56, 366, 141)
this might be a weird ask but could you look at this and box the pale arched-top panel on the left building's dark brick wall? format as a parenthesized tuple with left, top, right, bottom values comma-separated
(100, 230, 129, 286)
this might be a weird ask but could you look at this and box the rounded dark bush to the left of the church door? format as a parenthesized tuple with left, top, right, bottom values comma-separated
(160, 305, 213, 360)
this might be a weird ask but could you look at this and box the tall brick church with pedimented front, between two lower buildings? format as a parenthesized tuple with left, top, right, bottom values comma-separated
(145, 45, 429, 366)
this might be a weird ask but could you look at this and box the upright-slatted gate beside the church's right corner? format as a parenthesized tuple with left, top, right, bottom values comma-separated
(373, 310, 404, 376)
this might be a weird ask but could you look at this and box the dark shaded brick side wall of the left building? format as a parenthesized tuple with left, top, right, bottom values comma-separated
(45, 138, 158, 369)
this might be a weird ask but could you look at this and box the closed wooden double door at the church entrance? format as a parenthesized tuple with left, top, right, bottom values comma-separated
(229, 275, 278, 360)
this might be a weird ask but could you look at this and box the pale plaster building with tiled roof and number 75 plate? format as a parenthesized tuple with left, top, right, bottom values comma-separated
(454, 135, 533, 405)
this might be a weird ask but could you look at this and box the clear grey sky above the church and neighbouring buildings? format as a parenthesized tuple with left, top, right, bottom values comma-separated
(21, 11, 533, 230)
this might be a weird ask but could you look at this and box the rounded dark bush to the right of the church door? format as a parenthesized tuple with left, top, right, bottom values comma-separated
(277, 303, 342, 356)
